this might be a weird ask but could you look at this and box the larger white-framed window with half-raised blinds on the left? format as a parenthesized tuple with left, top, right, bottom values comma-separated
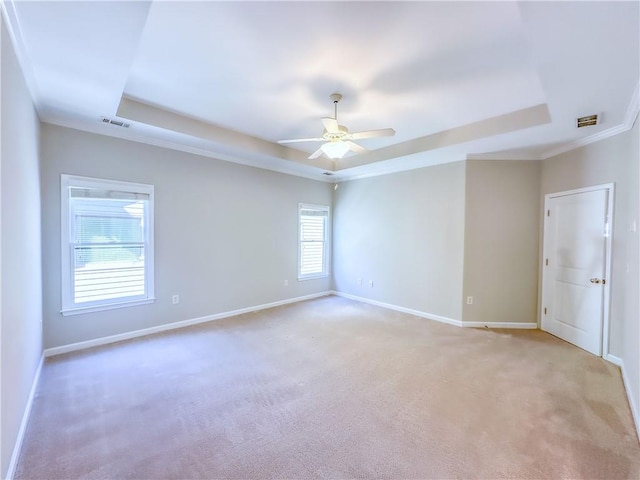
(61, 175, 154, 315)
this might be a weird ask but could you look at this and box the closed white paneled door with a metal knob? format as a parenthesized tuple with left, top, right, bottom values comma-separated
(541, 186, 612, 355)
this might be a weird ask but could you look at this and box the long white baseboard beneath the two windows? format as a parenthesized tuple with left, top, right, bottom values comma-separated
(44, 292, 332, 357)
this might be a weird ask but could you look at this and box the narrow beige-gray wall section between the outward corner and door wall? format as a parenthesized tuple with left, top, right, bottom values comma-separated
(462, 160, 541, 323)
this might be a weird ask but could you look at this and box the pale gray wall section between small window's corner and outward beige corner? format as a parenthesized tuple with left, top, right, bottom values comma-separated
(333, 162, 465, 320)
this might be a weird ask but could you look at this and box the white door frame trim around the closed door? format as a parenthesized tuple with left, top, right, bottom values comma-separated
(538, 183, 615, 359)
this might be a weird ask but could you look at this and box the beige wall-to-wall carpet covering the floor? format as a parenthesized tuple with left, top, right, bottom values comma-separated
(16, 297, 640, 479)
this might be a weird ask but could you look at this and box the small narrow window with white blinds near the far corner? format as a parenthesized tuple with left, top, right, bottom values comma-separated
(298, 203, 329, 280)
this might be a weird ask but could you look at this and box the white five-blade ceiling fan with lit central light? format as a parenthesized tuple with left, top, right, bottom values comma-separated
(278, 93, 396, 160)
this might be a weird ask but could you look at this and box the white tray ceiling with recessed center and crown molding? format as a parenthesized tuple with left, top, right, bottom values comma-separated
(3, 0, 640, 181)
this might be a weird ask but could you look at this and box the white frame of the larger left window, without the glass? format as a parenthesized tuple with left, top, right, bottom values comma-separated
(60, 174, 155, 316)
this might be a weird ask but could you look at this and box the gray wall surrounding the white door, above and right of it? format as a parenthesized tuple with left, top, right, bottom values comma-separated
(542, 120, 640, 432)
